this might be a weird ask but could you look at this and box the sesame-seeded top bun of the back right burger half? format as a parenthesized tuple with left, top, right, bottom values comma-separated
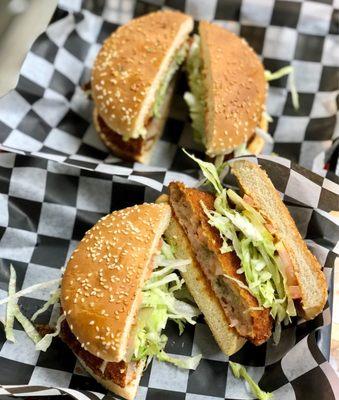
(199, 21, 267, 157)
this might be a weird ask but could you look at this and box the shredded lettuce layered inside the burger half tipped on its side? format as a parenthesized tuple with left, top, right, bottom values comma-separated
(186, 153, 296, 342)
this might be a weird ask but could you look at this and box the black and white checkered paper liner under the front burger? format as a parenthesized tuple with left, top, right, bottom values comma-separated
(0, 153, 339, 400)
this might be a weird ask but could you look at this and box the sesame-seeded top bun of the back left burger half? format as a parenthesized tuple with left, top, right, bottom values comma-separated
(91, 11, 193, 139)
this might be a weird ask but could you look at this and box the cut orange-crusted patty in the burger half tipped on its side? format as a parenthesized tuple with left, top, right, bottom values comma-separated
(169, 183, 272, 345)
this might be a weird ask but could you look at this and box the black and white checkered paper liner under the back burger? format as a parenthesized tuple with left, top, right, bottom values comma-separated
(0, 0, 339, 173)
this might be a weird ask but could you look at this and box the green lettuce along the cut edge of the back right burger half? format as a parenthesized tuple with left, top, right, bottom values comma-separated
(184, 35, 206, 143)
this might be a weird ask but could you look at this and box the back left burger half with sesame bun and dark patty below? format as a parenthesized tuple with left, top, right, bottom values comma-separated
(91, 11, 193, 162)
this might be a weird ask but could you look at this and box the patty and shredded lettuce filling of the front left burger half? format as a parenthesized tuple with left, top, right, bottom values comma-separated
(60, 241, 201, 387)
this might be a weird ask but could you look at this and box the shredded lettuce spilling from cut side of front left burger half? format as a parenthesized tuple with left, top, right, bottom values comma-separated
(134, 242, 200, 369)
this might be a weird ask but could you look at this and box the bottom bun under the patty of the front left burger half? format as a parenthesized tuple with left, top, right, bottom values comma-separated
(77, 356, 145, 400)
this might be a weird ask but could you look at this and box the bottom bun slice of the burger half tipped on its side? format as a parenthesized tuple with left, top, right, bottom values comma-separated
(157, 195, 246, 356)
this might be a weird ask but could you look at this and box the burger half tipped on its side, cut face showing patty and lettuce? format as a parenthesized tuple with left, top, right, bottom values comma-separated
(159, 158, 327, 355)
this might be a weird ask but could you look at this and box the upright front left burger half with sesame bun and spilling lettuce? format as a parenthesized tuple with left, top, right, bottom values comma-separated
(60, 203, 200, 399)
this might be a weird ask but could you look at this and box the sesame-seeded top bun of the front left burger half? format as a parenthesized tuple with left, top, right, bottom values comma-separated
(60, 203, 171, 362)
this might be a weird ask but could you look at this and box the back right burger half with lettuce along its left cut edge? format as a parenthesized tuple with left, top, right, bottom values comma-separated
(184, 21, 270, 158)
